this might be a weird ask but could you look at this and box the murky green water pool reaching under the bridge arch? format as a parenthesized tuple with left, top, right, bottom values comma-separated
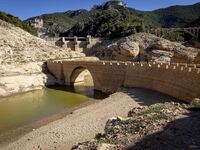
(0, 86, 106, 133)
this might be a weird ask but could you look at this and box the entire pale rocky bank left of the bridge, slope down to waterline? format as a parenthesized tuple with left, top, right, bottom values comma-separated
(0, 20, 84, 97)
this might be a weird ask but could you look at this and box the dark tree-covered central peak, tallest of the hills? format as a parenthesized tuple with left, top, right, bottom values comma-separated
(61, 3, 153, 38)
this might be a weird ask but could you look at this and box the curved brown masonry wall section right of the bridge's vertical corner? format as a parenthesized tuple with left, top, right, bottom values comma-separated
(124, 63, 200, 102)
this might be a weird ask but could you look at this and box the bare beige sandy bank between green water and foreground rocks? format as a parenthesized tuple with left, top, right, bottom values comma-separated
(0, 92, 138, 150)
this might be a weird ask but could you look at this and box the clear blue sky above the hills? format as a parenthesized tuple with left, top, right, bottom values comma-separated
(0, 0, 200, 20)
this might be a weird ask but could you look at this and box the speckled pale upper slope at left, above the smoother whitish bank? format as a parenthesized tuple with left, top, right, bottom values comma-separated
(0, 20, 83, 64)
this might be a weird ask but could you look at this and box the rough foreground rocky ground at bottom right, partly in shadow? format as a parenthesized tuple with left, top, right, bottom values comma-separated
(72, 100, 200, 150)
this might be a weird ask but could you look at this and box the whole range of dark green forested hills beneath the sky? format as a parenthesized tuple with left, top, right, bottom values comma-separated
(26, 0, 200, 37)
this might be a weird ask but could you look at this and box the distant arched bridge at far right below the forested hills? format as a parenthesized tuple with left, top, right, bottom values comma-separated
(149, 27, 200, 39)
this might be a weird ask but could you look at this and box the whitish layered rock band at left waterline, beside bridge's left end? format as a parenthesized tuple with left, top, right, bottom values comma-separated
(0, 62, 57, 97)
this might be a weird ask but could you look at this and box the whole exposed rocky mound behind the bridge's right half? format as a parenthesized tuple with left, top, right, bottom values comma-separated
(86, 33, 200, 62)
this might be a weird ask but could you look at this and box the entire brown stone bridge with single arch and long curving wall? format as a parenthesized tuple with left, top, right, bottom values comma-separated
(47, 61, 200, 102)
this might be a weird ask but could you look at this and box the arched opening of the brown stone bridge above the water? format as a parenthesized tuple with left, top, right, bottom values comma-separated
(70, 66, 94, 86)
